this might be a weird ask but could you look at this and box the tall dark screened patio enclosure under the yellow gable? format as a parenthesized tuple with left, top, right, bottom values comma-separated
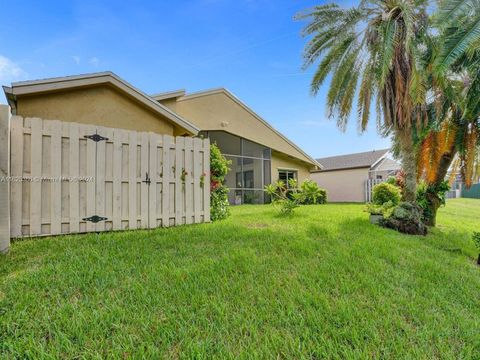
(201, 131, 272, 205)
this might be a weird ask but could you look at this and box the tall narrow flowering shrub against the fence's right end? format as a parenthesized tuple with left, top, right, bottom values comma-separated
(210, 144, 231, 221)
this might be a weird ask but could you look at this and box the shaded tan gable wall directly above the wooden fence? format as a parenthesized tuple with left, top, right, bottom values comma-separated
(17, 85, 180, 135)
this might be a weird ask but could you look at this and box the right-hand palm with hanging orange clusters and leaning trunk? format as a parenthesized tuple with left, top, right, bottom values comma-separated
(418, 30, 480, 225)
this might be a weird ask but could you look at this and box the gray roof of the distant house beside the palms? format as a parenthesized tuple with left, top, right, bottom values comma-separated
(316, 149, 390, 171)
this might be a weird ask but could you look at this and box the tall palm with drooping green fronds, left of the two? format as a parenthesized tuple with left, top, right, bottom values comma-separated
(297, 0, 428, 202)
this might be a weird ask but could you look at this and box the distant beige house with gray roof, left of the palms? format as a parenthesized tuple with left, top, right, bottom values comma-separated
(310, 149, 401, 202)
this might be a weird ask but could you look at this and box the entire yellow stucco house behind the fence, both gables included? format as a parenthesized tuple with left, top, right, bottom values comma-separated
(4, 72, 320, 204)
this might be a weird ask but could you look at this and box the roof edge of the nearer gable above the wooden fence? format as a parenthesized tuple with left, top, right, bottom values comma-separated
(3, 71, 200, 135)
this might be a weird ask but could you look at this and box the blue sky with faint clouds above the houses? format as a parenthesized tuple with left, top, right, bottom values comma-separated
(0, 0, 390, 158)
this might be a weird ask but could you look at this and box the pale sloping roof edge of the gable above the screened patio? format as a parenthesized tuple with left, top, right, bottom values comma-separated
(152, 88, 322, 169)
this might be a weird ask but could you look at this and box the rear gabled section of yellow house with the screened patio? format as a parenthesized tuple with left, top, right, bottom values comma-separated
(152, 88, 320, 204)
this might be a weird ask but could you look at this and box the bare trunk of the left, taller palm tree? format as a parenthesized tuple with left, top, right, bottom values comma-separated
(395, 129, 417, 202)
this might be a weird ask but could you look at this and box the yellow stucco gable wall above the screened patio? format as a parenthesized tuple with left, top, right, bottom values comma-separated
(160, 92, 314, 168)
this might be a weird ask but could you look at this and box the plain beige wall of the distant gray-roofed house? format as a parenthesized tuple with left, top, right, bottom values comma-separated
(310, 168, 370, 202)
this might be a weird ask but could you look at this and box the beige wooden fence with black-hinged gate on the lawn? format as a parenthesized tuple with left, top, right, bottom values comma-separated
(10, 116, 210, 237)
